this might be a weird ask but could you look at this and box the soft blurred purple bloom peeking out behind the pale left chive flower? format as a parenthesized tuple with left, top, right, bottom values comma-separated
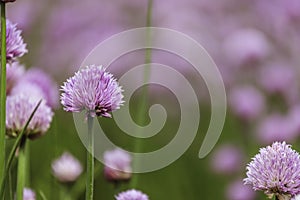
(21, 68, 59, 108)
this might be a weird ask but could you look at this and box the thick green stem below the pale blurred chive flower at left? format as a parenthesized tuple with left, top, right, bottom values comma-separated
(17, 136, 27, 200)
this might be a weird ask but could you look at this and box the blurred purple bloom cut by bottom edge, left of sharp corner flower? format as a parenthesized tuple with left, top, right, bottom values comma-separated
(226, 180, 255, 200)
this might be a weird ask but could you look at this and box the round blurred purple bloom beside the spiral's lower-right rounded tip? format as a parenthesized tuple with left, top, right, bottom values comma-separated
(212, 145, 243, 174)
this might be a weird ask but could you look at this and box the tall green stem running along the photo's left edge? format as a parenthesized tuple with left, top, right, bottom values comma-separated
(0, 2, 6, 194)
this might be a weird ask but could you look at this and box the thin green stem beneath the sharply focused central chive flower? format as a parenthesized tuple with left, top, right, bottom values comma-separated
(85, 115, 94, 200)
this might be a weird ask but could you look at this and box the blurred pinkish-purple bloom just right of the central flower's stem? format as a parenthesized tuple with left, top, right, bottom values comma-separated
(104, 148, 131, 182)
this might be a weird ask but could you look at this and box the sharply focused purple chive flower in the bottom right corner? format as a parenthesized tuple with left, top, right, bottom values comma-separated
(244, 142, 300, 199)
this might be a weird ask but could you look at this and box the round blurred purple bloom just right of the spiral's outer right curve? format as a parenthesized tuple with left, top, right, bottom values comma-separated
(229, 86, 265, 120)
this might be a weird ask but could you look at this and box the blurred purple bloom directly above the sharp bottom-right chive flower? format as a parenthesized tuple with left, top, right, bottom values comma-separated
(257, 114, 298, 144)
